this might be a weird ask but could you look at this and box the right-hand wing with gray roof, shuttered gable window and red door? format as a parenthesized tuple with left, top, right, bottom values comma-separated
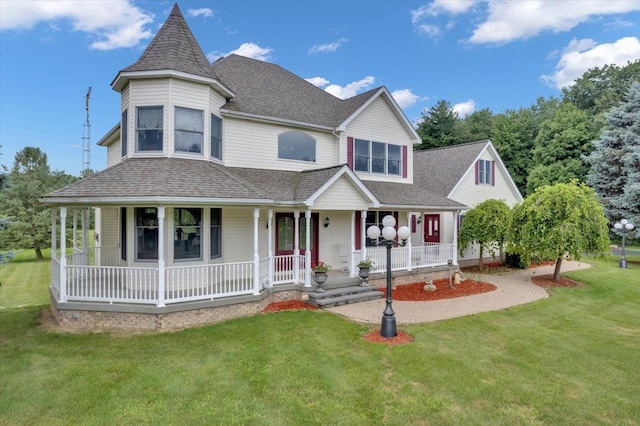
(413, 140, 523, 265)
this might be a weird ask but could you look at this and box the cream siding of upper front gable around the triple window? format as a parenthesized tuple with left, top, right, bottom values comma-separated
(341, 97, 415, 183)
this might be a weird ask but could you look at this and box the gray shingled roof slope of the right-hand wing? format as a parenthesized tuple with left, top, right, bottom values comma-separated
(413, 140, 489, 197)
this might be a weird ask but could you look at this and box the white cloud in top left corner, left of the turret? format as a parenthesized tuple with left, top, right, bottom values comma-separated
(0, 0, 154, 50)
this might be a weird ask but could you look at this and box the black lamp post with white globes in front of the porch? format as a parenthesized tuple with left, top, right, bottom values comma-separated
(367, 215, 411, 338)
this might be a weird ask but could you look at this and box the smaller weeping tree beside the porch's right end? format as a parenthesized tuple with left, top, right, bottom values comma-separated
(458, 199, 511, 269)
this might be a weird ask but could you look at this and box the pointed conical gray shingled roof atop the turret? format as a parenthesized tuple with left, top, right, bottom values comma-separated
(115, 4, 215, 79)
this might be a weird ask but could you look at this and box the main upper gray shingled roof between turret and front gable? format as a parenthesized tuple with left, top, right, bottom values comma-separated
(212, 54, 380, 128)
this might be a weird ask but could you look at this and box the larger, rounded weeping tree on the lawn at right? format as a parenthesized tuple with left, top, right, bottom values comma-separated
(508, 181, 610, 281)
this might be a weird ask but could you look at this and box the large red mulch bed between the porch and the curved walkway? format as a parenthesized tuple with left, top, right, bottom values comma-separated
(378, 278, 496, 301)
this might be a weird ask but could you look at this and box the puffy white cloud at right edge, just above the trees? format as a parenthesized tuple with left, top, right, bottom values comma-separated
(541, 37, 640, 89)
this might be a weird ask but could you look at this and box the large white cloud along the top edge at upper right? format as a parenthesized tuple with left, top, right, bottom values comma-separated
(469, 0, 640, 44)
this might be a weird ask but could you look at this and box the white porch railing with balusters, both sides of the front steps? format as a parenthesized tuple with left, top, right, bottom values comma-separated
(51, 244, 455, 305)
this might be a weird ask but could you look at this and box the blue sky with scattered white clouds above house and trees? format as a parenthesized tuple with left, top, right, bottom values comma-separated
(0, 0, 640, 175)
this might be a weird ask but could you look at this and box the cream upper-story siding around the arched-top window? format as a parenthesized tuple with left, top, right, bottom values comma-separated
(223, 117, 338, 171)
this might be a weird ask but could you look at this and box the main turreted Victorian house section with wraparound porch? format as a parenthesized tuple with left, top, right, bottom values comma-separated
(42, 5, 516, 330)
